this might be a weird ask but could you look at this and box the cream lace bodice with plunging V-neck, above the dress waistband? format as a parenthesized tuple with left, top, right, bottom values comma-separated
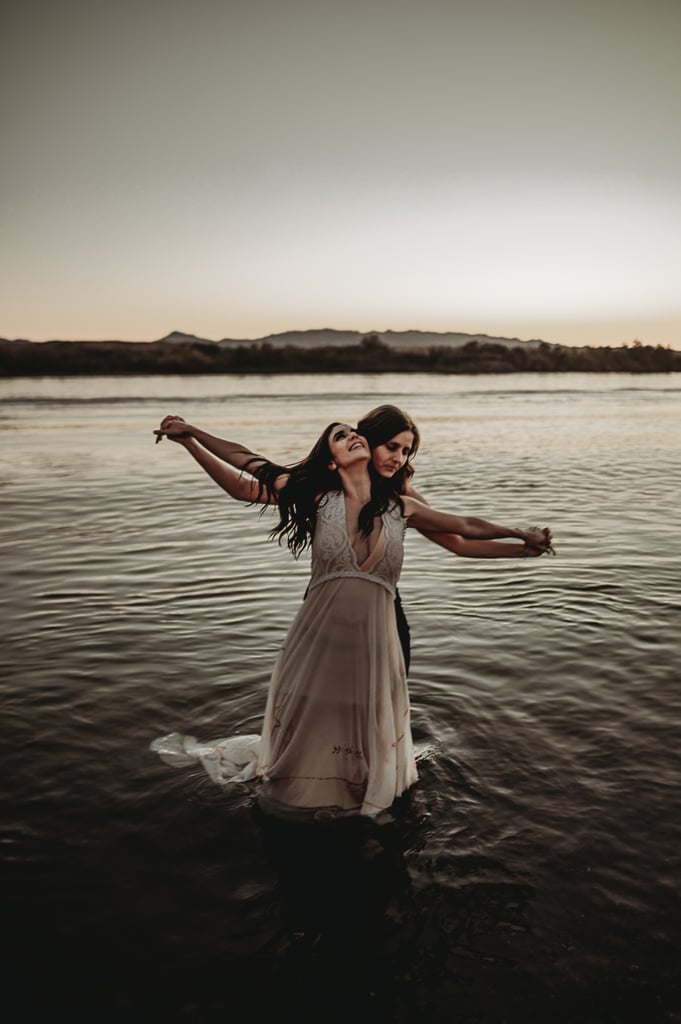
(310, 490, 407, 595)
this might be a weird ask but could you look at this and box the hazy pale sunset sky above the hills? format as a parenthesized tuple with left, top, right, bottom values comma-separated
(0, 0, 681, 348)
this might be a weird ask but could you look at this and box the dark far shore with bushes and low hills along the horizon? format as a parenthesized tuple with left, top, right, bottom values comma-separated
(0, 330, 681, 377)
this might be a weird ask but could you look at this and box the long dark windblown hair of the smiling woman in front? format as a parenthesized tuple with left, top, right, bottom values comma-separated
(244, 420, 405, 558)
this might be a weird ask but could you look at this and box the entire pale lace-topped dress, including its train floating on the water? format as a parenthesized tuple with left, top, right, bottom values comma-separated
(152, 492, 417, 817)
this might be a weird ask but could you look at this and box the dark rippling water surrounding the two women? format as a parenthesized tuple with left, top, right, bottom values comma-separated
(0, 375, 681, 1024)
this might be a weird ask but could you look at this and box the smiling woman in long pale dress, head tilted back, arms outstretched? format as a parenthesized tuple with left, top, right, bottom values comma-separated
(153, 417, 551, 817)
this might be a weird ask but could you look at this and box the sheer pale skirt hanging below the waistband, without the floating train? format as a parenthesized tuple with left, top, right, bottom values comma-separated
(257, 575, 417, 815)
